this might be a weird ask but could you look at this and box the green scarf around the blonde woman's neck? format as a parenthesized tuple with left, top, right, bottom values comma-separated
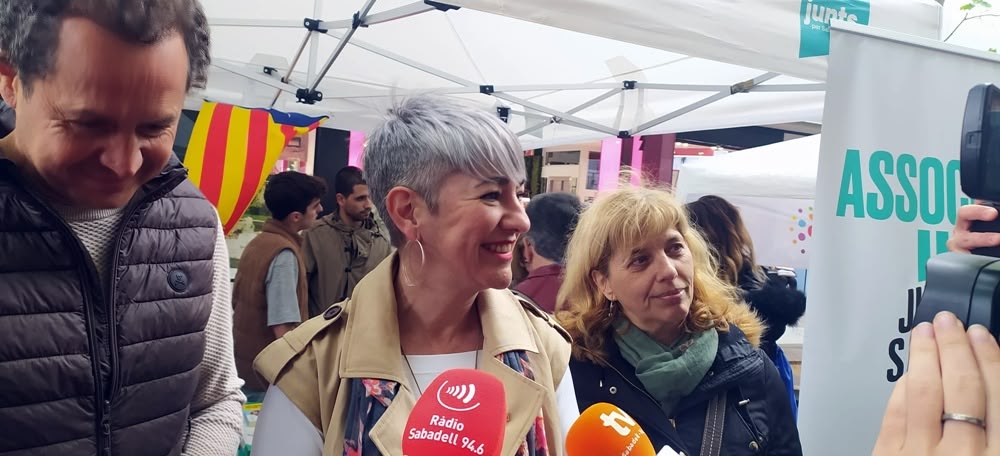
(615, 316, 719, 416)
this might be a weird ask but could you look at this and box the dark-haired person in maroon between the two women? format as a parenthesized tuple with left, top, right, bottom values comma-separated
(515, 193, 580, 313)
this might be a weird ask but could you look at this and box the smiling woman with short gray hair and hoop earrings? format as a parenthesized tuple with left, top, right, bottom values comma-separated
(253, 97, 579, 456)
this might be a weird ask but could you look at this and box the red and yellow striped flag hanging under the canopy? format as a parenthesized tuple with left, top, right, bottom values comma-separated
(184, 102, 327, 234)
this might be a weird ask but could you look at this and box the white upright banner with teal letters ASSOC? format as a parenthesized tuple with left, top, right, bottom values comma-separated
(799, 24, 1000, 456)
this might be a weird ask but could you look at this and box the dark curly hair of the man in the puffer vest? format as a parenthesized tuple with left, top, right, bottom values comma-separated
(0, 0, 212, 93)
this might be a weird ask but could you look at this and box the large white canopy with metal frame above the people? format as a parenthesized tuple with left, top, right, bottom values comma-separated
(199, 0, 940, 148)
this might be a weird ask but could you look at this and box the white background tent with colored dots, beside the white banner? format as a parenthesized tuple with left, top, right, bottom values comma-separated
(676, 135, 820, 268)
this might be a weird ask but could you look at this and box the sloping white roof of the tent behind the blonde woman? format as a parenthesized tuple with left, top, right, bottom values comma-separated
(677, 135, 821, 201)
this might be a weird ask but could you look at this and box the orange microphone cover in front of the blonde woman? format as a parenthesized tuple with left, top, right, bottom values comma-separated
(566, 402, 669, 456)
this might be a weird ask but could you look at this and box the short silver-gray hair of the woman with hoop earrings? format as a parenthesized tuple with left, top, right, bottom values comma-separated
(364, 95, 525, 247)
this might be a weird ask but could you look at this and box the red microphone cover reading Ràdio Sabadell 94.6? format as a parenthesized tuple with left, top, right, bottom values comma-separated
(403, 369, 507, 456)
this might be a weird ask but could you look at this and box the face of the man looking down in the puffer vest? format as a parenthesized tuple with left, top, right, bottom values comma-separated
(0, 18, 188, 209)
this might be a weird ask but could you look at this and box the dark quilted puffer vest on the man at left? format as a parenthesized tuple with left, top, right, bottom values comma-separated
(0, 156, 218, 456)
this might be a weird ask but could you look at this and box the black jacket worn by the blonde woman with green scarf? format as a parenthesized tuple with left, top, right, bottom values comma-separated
(570, 325, 802, 456)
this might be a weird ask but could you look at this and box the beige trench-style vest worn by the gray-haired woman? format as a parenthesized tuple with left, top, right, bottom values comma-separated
(254, 254, 570, 456)
